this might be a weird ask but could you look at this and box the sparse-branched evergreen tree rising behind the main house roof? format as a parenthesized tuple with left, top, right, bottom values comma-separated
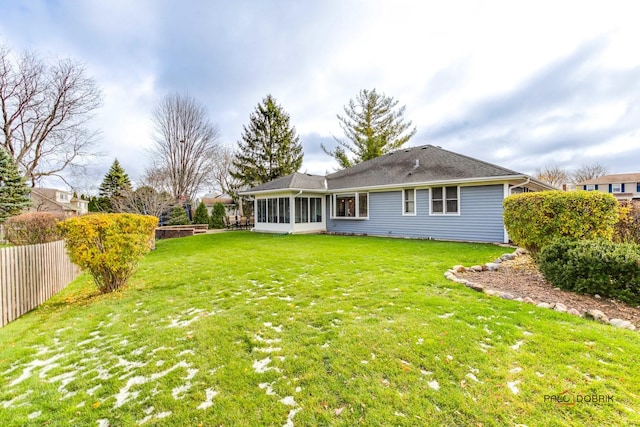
(321, 89, 416, 168)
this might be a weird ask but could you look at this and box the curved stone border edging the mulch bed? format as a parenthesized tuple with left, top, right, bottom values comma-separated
(444, 248, 636, 331)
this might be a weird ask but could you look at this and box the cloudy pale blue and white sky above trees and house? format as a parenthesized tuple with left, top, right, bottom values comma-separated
(0, 0, 640, 194)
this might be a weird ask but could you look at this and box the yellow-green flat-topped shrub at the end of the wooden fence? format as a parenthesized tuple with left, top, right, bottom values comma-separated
(58, 214, 158, 293)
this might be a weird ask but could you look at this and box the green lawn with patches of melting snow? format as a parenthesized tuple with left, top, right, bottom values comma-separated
(0, 232, 640, 427)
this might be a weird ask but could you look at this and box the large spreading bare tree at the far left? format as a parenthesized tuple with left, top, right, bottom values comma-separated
(0, 46, 102, 186)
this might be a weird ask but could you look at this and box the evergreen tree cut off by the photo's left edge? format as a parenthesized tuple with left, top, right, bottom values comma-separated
(0, 147, 31, 223)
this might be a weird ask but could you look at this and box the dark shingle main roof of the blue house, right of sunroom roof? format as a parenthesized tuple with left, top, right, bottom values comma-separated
(327, 145, 523, 190)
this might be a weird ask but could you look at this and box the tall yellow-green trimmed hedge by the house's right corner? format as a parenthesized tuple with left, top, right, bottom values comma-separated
(503, 191, 618, 255)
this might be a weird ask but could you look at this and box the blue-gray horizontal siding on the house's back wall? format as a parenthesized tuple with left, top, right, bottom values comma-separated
(327, 185, 504, 242)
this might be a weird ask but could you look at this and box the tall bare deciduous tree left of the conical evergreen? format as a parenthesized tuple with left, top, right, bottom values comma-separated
(147, 94, 219, 200)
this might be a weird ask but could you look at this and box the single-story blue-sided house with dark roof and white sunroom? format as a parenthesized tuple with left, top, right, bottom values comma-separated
(241, 145, 554, 242)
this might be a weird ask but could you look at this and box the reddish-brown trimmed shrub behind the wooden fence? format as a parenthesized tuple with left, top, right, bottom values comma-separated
(4, 212, 65, 245)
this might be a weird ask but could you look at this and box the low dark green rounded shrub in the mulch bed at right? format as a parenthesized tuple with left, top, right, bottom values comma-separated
(538, 238, 640, 304)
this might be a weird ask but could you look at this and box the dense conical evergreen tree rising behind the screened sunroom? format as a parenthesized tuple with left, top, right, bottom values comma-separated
(231, 95, 303, 187)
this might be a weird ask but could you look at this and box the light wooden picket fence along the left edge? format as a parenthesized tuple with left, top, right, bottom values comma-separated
(0, 240, 80, 327)
